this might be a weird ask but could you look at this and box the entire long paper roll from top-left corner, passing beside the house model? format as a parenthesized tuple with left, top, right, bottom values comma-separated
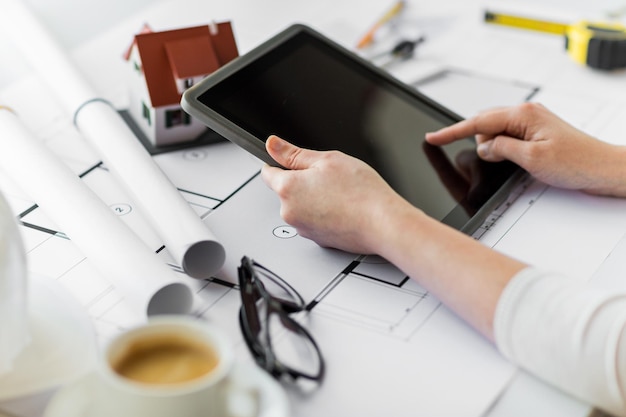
(0, 0, 226, 278)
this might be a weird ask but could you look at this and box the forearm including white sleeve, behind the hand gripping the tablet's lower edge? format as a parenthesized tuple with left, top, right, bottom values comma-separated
(378, 202, 626, 415)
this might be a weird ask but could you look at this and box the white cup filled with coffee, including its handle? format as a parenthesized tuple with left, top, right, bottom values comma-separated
(90, 316, 273, 417)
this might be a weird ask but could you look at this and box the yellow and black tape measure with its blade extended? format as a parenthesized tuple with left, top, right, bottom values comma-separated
(485, 11, 626, 70)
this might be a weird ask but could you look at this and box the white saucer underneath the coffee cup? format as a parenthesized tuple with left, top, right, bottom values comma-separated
(44, 364, 289, 417)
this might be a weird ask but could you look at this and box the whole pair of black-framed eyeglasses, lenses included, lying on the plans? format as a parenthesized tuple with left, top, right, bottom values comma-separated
(237, 256, 325, 382)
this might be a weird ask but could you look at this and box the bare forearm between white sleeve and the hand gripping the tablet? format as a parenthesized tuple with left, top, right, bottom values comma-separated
(376, 202, 525, 340)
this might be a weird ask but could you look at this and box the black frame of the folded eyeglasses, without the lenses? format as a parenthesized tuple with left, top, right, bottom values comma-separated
(237, 256, 325, 383)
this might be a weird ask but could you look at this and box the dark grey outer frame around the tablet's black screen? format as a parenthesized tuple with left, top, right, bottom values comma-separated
(181, 24, 524, 234)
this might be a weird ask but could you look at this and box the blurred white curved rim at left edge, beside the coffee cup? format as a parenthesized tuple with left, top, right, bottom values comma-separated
(0, 274, 96, 401)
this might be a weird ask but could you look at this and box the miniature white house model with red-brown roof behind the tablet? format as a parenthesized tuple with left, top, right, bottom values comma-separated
(124, 22, 239, 147)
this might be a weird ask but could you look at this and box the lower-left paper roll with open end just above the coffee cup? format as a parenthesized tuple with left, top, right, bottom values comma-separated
(0, 106, 193, 316)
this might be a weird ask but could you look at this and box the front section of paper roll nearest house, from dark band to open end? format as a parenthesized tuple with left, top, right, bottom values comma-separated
(75, 100, 225, 278)
